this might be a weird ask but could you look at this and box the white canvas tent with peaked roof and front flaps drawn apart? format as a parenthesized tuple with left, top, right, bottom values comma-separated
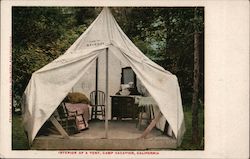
(23, 8, 185, 147)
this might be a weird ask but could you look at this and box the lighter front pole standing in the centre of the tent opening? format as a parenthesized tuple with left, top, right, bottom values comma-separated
(105, 48, 109, 138)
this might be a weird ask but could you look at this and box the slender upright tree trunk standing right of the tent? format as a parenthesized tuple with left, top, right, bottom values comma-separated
(192, 32, 199, 144)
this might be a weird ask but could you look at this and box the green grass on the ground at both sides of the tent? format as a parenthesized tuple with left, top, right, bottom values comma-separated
(12, 107, 204, 150)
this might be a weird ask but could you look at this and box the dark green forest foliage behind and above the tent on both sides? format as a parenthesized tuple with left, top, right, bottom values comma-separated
(12, 7, 204, 149)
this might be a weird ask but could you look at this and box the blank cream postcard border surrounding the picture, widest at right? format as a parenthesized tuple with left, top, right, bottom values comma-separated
(0, 0, 249, 158)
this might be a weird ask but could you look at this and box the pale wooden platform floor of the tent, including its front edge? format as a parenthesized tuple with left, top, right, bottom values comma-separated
(31, 120, 176, 150)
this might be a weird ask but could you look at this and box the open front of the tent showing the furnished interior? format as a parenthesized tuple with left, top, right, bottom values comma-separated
(38, 49, 174, 138)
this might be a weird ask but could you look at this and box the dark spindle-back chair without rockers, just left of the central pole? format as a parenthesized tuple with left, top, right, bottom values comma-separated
(90, 90, 105, 119)
